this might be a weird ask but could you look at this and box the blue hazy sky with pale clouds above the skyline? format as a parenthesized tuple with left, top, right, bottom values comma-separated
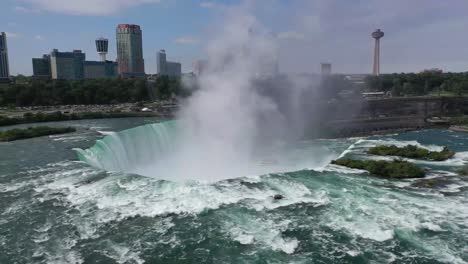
(0, 0, 468, 74)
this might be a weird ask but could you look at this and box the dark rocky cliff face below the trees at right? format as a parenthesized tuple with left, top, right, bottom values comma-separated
(309, 97, 468, 137)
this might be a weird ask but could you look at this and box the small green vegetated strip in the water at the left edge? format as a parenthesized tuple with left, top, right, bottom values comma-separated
(0, 126, 76, 141)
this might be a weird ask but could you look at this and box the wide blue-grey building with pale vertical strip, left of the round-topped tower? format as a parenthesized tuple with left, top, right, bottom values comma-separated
(50, 49, 86, 80)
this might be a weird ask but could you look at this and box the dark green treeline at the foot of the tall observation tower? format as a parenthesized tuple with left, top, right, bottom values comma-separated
(365, 71, 468, 96)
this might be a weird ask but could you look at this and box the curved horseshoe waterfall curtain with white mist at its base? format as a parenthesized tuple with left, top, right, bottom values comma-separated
(75, 121, 332, 181)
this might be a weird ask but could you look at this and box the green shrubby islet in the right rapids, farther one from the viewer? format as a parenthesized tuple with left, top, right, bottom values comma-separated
(368, 145, 455, 161)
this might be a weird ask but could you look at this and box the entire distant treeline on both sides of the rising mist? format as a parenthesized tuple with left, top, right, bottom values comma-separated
(5, 71, 468, 106)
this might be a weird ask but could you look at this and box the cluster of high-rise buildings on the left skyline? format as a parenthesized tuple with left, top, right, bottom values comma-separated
(26, 24, 182, 80)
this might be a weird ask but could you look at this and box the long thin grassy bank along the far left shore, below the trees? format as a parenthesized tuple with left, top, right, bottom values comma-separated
(0, 111, 156, 126)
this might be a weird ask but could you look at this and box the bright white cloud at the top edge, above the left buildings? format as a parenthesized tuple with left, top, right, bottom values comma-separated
(24, 0, 160, 16)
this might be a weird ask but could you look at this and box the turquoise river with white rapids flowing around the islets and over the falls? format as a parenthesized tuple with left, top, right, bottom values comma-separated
(0, 118, 468, 263)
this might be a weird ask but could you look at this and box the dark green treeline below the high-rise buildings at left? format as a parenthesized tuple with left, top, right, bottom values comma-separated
(0, 76, 187, 106)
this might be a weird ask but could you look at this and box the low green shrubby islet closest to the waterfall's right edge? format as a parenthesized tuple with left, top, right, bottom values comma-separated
(331, 158, 426, 179)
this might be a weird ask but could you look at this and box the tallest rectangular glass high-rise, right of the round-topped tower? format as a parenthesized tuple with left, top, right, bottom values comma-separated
(117, 24, 145, 77)
